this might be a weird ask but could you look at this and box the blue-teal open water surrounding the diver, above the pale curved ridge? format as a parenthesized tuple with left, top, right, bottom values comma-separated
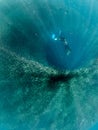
(0, 0, 98, 69)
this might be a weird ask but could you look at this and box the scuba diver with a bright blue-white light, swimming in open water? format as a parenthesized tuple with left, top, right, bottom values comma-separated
(52, 31, 71, 55)
